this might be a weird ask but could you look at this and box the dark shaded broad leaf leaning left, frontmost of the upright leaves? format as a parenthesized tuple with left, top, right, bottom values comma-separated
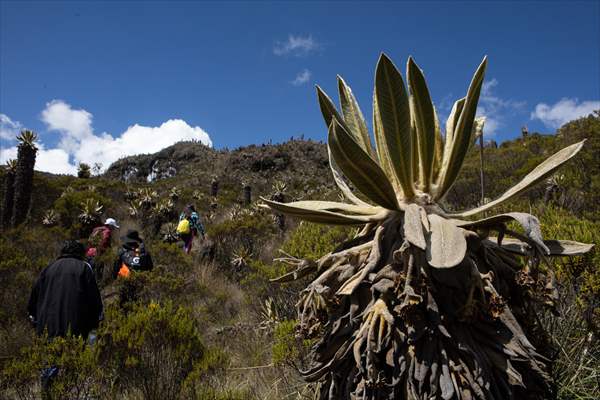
(329, 118, 398, 210)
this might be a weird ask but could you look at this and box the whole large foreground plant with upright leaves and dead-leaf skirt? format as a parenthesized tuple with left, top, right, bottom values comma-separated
(263, 54, 593, 400)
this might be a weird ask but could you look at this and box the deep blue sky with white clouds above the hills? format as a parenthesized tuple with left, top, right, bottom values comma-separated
(0, 1, 600, 173)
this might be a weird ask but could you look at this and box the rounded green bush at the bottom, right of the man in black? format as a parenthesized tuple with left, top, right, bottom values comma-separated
(98, 302, 206, 400)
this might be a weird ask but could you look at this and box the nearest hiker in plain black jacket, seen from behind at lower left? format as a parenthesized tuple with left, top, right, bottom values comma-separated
(27, 240, 103, 398)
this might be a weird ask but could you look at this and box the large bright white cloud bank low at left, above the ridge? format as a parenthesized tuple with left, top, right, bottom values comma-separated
(0, 100, 212, 174)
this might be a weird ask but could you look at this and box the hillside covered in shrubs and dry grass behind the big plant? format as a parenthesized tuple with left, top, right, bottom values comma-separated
(0, 114, 600, 400)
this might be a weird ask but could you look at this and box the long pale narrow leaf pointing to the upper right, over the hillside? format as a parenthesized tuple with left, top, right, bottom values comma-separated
(449, 139, 585, 218)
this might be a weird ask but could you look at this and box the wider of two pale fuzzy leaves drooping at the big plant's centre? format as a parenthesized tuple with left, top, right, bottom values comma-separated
(425, 214, 467, 268)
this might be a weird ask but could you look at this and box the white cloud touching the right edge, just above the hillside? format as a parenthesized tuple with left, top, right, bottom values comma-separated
(531, 97, 600, 128)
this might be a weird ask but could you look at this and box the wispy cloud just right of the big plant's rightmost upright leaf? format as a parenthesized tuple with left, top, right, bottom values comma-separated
(477, 78, 526, 137)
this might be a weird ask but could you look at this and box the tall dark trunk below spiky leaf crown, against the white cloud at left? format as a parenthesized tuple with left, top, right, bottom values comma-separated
(11, 144, 36, 227)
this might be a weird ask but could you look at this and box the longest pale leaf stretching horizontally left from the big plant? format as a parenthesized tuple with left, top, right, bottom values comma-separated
(261, 198, 380, 225)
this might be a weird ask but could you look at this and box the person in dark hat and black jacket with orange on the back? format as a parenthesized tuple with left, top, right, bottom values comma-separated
(113, 229, 154, 307)
